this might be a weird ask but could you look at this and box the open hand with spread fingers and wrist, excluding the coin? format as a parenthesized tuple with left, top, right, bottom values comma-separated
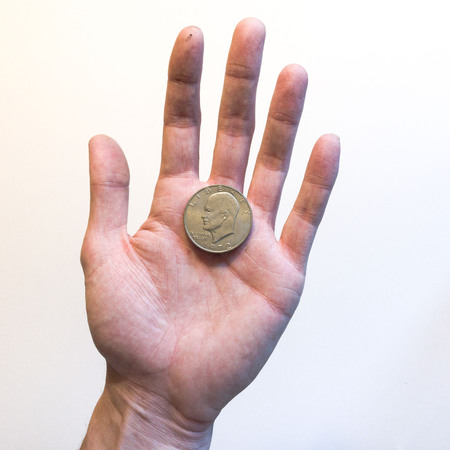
(82, 19, 339, 448)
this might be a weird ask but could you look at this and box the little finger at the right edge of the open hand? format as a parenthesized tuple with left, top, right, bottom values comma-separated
(280, 134, 340, 271)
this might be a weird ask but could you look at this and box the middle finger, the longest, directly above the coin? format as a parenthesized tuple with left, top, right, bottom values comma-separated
(210, 19, 265, 190)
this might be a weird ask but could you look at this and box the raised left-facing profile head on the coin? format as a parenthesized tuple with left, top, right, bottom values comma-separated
(202, 192, 239, 243)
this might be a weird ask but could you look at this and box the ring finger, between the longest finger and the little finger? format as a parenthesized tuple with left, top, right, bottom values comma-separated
(248, 65, 308, 227)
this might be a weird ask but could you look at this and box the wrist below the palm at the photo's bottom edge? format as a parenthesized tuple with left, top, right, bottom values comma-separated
(81, 371, 213, 449)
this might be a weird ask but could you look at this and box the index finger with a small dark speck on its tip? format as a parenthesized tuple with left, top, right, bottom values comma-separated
(160, 27, 203, 177)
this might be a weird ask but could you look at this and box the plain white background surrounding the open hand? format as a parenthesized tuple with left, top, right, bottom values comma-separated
(0, 0, 450, 450)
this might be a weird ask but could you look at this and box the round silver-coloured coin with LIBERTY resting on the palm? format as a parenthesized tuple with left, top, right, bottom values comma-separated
(184, 184, 253, 253)
